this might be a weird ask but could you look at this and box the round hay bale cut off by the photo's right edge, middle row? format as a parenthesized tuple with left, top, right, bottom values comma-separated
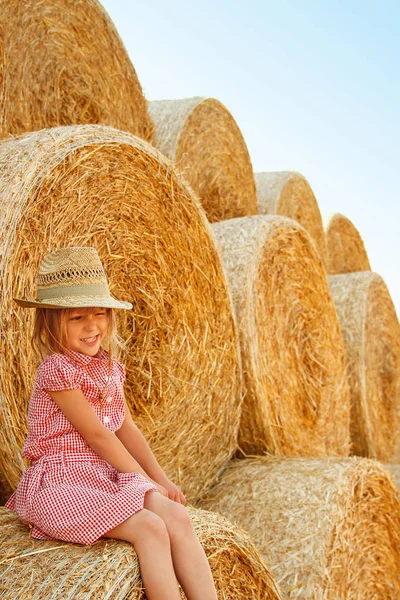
(329, 271, 400, 462)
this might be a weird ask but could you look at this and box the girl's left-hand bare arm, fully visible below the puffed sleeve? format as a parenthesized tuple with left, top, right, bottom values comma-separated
(47, 390, 165, 495)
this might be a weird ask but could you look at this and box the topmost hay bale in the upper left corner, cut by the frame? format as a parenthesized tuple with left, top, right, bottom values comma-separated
(0, 0, 154, 141)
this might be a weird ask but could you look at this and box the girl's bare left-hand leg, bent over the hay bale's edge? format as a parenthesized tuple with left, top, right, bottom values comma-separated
(103, 506, 180, 600)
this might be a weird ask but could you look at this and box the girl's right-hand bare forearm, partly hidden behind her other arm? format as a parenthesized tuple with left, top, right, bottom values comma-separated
(115, 408, 186, 503)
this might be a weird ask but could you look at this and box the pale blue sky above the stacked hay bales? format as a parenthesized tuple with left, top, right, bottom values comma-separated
(101, 0, 400, 315)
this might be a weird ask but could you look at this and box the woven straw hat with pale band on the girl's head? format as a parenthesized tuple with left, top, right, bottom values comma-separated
(14, 247, 132, 309)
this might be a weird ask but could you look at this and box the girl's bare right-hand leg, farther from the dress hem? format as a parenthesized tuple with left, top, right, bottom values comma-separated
(144, 494, 217, 600)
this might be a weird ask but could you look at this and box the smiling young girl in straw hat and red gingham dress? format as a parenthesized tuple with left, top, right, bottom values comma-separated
(6, 248, 217, 600)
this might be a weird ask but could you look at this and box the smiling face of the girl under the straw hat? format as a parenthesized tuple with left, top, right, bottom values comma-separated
(67, 308, 108, 356)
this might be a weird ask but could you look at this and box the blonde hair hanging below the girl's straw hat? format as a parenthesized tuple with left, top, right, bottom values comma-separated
(32, 308, 125, 359)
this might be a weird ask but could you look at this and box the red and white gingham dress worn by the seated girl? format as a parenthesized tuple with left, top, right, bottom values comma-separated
(6, 350, 156, 544)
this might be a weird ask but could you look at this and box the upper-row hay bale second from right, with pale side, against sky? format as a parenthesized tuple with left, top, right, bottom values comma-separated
(254, 171, 327, 264)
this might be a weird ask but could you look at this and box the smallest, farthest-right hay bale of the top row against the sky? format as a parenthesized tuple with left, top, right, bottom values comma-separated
(325, 213, 371, 275)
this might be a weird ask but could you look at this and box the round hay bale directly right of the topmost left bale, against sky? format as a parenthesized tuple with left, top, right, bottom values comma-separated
(149, 97, 257, 221)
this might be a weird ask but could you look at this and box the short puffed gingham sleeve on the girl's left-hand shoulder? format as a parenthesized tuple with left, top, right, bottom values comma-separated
(36, 354, 83, 392)
